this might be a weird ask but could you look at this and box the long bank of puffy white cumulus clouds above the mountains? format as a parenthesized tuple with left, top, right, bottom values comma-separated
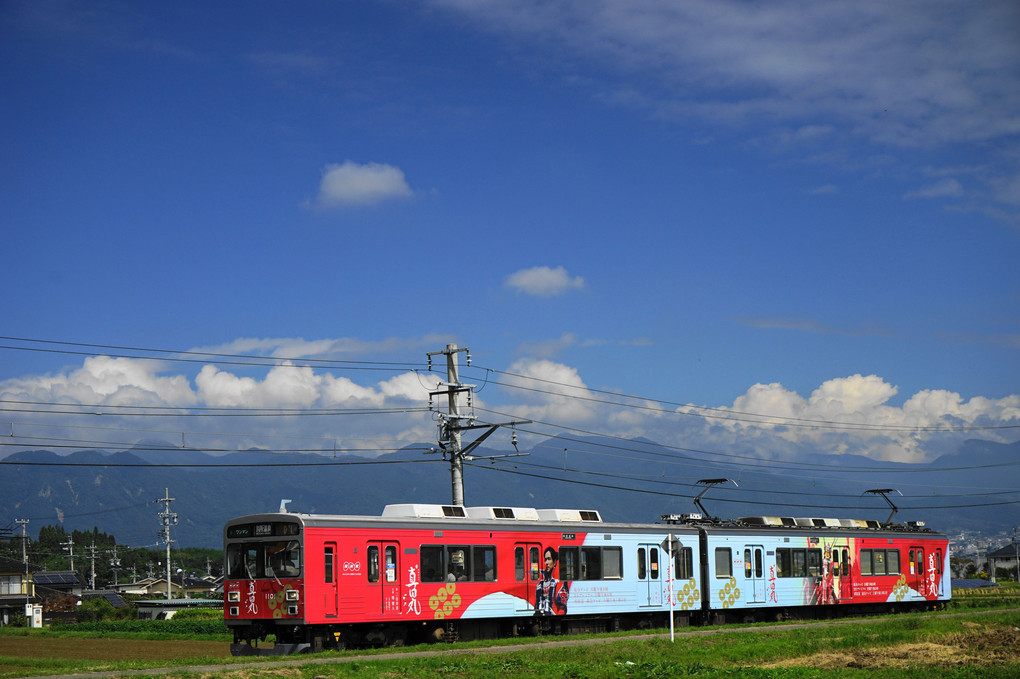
(0, 334, 1020, 462)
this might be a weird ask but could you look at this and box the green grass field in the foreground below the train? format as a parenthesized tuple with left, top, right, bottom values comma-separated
(0, 609, 1020, 679)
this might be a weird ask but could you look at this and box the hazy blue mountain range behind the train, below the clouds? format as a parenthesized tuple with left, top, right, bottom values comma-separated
(0, 437, 1020, 546)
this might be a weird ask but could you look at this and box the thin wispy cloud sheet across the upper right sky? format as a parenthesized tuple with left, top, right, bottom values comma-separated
(437, 0, 1020, 146)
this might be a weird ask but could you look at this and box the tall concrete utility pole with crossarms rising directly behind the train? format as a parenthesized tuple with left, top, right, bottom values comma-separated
(425, 344, 530, 507)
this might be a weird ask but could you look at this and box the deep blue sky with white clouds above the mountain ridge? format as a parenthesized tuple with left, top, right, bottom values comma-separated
(0, 0, 1020, 462)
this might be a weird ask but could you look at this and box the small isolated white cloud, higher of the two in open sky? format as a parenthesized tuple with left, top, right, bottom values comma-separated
(308, 160, 414, 209)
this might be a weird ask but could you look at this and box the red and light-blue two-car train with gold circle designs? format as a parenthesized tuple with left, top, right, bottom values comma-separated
(223, 504, 952, 656)
